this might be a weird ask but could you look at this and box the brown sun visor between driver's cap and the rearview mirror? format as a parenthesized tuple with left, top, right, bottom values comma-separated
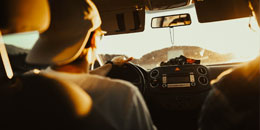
(93, 0, 145, 35)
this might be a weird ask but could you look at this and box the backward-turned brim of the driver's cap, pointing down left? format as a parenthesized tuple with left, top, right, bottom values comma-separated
(26, 25, 90, 65)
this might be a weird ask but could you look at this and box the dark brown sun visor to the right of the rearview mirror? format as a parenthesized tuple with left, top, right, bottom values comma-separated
(195, 0, 252, 23)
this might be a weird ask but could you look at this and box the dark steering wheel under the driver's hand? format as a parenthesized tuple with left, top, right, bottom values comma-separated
(106, 62, 145, 94)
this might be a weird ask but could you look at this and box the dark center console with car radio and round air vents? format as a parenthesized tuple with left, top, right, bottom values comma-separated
(144, 64, 211, 130)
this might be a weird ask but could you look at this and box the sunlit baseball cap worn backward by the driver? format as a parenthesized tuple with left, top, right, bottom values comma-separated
(26, 0, 101, 65)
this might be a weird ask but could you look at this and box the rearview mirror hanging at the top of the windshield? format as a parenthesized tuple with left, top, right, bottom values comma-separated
(152, 14, 191, 28)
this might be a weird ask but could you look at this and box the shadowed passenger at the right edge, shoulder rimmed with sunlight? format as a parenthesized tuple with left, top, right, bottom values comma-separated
(199, 0, 260, 130)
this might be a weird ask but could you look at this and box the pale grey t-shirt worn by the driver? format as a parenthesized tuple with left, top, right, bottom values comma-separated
(42, 68, 156, 130)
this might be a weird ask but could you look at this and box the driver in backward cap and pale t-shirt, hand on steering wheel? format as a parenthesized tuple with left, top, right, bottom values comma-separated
(26, 0, 156, 130)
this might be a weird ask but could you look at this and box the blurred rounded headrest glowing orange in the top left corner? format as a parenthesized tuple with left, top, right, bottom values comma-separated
(0, 0, 50, 34)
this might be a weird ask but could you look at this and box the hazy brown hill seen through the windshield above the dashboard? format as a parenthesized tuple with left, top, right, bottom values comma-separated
(99, 46, 233, 68)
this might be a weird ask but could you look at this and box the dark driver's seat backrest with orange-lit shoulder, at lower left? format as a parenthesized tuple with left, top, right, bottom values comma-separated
(0, 70, 91, 130)
